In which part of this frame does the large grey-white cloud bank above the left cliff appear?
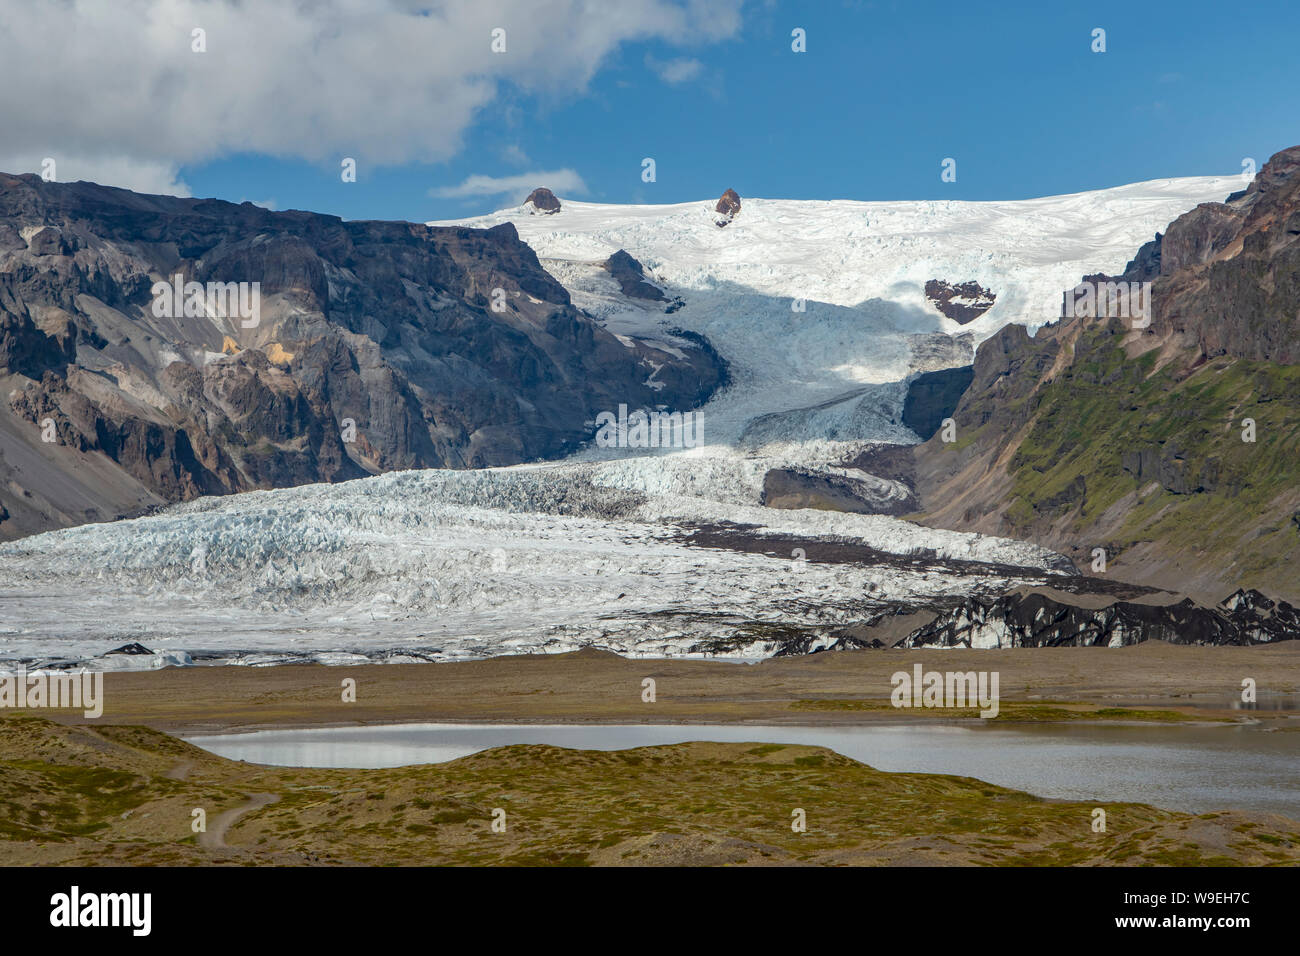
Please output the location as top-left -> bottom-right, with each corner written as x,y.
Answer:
0,0 -> 742,191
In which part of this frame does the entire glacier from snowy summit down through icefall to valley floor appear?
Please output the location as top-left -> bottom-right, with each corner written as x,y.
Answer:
0,177 -> 1239,667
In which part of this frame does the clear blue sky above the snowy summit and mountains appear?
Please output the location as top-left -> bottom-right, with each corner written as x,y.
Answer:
10,0 -> 1300,220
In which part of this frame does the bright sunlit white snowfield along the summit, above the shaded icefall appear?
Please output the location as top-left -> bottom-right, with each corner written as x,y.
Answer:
430,176 -> 1242,336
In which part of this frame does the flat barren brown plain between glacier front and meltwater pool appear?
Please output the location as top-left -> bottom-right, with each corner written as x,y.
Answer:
32,641 -> 1300,734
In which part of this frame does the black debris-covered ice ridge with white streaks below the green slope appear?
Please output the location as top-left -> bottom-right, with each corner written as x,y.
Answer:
898,591 -> 1300,648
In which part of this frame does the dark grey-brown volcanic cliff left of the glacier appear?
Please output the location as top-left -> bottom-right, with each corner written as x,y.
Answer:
0,174 -> 723,538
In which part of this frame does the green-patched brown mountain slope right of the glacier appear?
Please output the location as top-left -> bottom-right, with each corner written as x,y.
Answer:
904,147 -> 1300,602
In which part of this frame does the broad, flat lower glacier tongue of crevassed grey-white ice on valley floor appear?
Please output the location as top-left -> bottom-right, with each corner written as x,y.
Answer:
0,458 -> 1054,661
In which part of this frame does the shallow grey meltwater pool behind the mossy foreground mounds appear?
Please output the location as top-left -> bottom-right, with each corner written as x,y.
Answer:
186,722 -> 1300,819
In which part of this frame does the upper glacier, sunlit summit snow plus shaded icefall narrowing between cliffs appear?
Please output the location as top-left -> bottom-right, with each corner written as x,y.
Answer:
430,177 -> 1240,450
